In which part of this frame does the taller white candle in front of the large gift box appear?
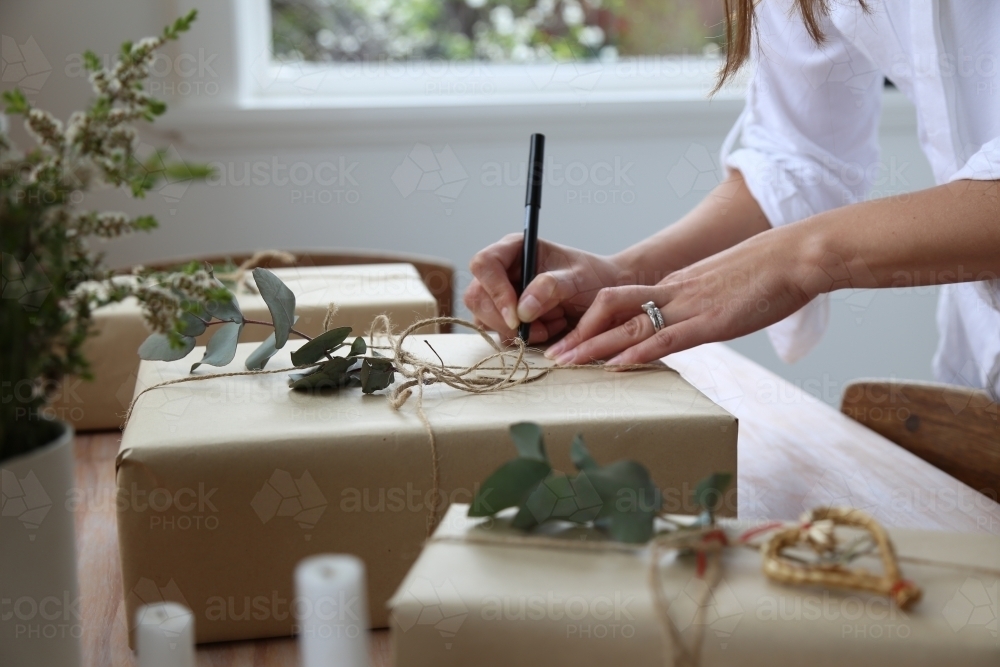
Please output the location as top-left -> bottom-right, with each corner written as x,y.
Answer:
295,555 -> 369,667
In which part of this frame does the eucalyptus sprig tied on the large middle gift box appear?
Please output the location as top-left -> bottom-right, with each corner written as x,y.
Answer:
139,267 -> 395,394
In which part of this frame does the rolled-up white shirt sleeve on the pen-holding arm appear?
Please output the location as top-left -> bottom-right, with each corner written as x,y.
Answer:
722,0 -> 883,362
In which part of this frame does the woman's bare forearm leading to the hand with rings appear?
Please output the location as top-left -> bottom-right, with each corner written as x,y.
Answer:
788,181 -> 1000,296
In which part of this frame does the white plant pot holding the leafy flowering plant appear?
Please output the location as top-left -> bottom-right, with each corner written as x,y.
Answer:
0,424 -> 82,667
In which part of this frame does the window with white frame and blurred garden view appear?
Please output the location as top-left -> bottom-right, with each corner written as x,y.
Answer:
242,0 -> 722,109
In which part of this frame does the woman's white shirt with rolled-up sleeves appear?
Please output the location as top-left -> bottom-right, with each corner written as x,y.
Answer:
722,0 -> 1000,399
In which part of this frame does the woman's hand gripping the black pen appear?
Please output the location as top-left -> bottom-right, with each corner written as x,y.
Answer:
464,234 -> 630,343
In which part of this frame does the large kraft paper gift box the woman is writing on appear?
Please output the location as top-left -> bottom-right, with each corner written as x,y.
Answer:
117,334 -> 737,642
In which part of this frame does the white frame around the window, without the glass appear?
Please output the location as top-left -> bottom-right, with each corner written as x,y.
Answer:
235,0 -> 732,108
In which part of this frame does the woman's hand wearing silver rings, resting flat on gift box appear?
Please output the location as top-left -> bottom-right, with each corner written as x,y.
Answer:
546,228 -> 820,364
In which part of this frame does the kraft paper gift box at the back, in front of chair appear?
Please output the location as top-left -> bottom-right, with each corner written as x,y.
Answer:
50,264 -> 437,431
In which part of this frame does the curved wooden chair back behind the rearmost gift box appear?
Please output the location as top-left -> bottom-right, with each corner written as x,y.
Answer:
135,249 -> 455,333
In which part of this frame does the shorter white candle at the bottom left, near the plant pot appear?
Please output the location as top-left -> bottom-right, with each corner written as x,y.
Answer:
135,602 -> 194,667
